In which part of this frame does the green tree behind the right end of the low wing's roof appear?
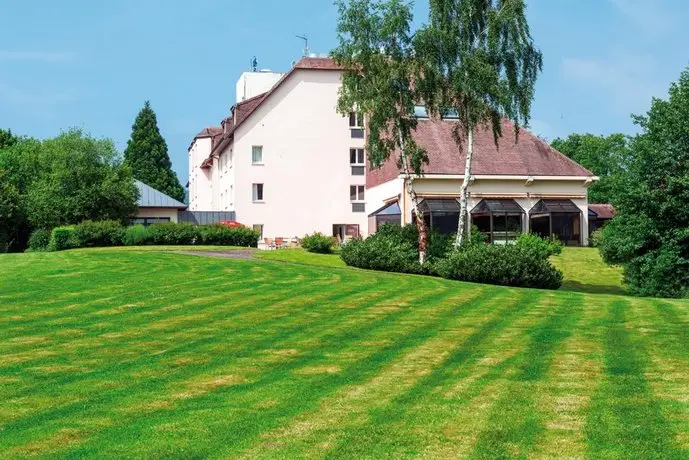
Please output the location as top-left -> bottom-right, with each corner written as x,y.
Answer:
552,134 -> 631,203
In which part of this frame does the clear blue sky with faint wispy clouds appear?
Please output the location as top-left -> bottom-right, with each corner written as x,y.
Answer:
0,0 -> 689,183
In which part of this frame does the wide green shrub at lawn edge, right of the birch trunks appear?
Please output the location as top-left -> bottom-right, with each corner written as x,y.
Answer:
435,244 -> 562,289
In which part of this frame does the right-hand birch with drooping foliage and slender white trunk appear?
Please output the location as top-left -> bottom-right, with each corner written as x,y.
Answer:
415,0 -> 542,246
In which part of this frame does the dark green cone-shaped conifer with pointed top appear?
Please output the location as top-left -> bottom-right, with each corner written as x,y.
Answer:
124,101 -> 184,201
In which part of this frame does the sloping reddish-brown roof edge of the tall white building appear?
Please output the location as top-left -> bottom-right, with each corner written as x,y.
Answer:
211,57 -> 342,156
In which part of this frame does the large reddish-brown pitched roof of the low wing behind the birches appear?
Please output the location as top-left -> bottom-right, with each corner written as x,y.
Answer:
366,120 -> 594,187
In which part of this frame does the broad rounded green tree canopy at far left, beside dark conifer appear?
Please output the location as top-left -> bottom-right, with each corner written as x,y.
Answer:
0,130 -> 138,250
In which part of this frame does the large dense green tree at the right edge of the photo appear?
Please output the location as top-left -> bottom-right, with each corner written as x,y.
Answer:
600,69 -> 689,297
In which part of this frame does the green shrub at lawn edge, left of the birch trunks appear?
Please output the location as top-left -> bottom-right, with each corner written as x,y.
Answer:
340,237 -> 423,273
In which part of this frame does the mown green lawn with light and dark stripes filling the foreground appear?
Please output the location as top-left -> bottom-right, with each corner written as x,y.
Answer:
0,250 -> 689,458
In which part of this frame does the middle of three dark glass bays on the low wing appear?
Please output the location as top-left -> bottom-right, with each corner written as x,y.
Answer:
471,199 -> 525,244
